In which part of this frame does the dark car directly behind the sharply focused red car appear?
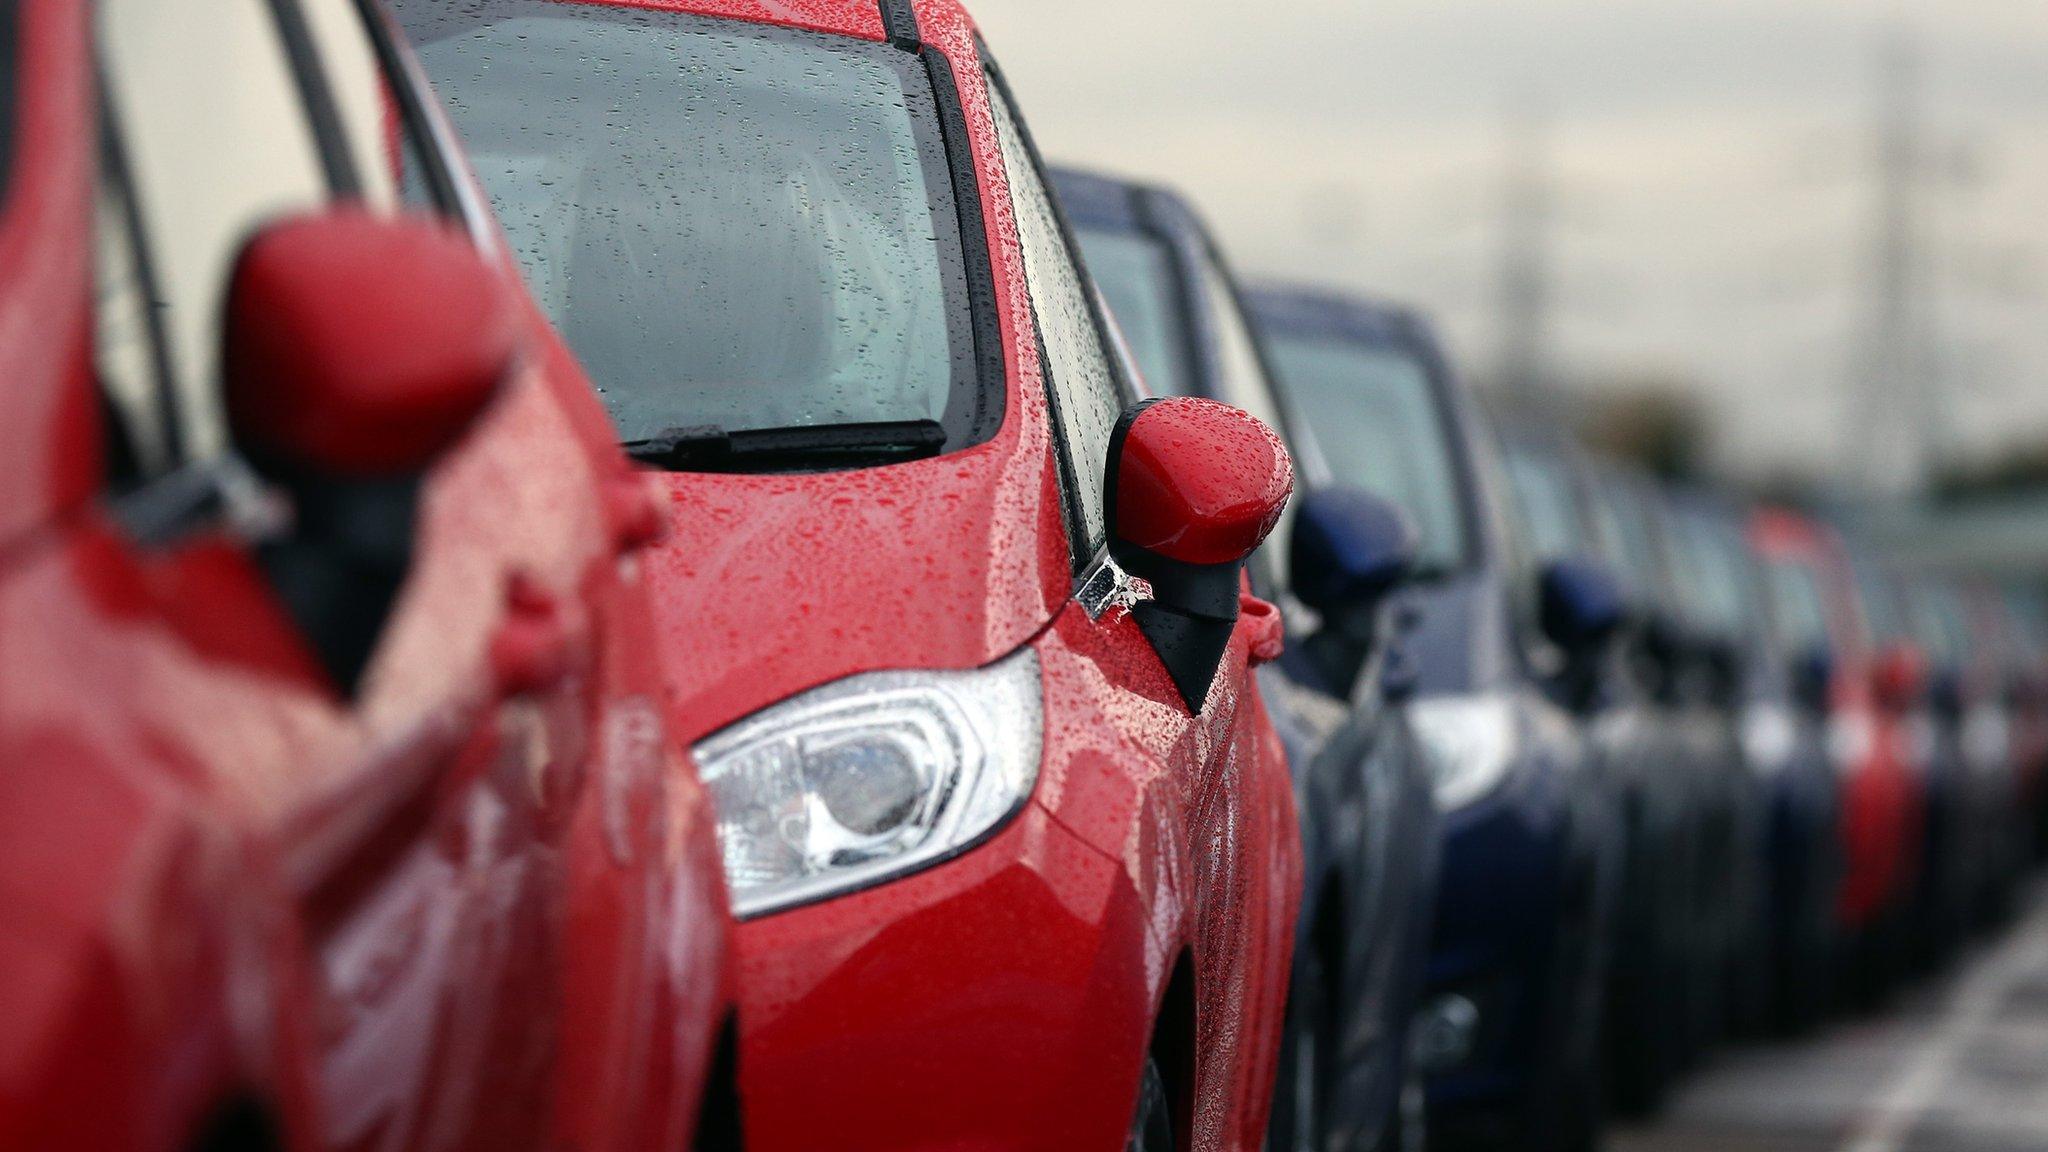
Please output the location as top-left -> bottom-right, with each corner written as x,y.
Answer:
1053,172 -> 1438,1152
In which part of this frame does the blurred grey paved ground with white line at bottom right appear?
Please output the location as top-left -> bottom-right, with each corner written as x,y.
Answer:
1612,888 -> 2048,1152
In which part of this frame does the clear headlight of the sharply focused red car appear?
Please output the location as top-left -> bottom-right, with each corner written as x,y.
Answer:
696,648 -> 1044,918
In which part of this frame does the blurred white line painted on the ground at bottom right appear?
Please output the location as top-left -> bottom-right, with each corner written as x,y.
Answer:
1841,914 -> 2048,1152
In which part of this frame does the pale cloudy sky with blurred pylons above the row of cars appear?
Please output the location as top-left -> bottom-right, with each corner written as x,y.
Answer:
975,0 -> 2048,572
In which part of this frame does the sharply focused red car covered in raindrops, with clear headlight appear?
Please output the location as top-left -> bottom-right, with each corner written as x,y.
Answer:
397,0 -> 1300,1152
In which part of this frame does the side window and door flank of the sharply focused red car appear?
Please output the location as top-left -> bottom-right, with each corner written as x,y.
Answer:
989,62 -> 1300,1146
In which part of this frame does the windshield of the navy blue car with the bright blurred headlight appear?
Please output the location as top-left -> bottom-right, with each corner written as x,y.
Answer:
1268,330 -> 1466,574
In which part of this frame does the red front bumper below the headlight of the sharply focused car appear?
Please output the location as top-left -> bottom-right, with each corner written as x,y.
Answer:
737,804 -> 1167,1152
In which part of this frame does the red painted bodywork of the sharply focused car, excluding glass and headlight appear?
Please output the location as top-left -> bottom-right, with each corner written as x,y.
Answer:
485,0 -> 1300,1152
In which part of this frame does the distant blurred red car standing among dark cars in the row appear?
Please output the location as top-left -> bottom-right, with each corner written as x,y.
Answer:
1751,510 -> 1921,931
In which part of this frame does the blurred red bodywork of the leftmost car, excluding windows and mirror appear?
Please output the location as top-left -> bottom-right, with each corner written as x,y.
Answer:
0,0 -> 729,1152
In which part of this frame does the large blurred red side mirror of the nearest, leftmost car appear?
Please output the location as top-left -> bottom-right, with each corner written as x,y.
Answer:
221,207 -> 520,480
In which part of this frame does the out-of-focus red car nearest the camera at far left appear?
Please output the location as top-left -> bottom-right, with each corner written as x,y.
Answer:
0,0 -> 733,1152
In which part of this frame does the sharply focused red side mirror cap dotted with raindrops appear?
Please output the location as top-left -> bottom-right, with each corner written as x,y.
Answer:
1108,396 -> 1294,566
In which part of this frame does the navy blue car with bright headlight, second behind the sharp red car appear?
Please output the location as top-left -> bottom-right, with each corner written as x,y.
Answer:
1247,289 -> 1622,1150
